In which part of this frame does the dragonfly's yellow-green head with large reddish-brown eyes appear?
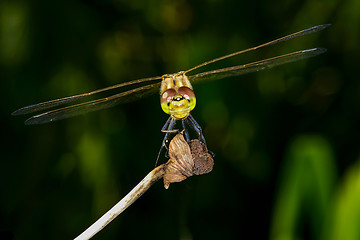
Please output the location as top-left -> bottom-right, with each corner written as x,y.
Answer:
160,87 -> 196,119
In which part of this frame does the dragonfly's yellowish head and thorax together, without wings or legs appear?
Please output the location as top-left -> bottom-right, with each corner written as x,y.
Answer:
160,72 -> 196,119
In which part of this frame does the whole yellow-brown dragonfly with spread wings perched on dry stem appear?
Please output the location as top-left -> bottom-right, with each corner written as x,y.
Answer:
12,24 -> 330,156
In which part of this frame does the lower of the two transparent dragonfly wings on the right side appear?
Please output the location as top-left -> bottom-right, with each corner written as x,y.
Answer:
188,48 -> 326,83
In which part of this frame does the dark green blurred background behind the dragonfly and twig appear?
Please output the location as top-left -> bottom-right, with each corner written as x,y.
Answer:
0,0 -> 360,240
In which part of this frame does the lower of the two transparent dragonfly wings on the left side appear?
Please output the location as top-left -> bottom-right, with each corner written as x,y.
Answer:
25,83 -> 160,125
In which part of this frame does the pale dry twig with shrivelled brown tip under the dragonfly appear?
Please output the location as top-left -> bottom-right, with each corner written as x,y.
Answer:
75,133 -> 214,240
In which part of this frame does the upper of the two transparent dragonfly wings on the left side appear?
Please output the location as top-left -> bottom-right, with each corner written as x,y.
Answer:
12,77 -> 161,115
